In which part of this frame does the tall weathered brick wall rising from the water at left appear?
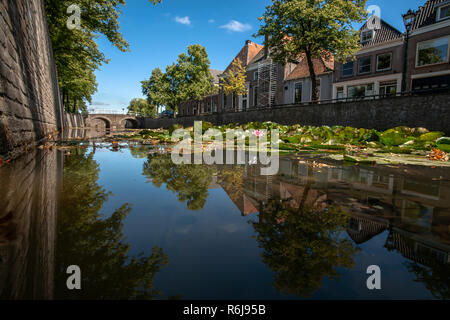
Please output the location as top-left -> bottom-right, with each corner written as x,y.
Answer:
0,0 -> 63,157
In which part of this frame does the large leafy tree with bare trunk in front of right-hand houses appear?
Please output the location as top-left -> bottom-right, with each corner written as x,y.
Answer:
256,0 -> 367,101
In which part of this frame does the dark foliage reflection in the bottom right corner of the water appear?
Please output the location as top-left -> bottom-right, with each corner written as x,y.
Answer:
405,262 -> 450,300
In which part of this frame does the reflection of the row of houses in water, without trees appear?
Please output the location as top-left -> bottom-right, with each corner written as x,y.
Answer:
222,158 -> 450,248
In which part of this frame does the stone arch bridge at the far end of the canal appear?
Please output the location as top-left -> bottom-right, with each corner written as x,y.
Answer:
85,113 -> 141,130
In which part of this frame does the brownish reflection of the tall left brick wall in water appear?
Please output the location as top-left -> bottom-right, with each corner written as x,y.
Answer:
0,150 -> 63,299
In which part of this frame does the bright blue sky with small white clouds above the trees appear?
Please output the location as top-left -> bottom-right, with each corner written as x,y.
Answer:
91,0 -> 425,110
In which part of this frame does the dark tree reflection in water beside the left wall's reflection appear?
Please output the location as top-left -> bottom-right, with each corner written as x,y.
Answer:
55,150 -> 168,299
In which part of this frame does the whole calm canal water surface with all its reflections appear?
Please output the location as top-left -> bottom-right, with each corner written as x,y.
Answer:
0,133 -> 450,299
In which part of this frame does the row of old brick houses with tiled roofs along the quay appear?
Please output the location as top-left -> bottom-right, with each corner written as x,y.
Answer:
180,0 -> 450,116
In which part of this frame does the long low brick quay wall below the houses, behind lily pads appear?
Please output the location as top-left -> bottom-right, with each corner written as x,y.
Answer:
142,93 -> 450,134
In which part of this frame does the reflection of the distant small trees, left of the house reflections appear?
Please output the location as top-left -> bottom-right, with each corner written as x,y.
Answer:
144,154 -> 213,210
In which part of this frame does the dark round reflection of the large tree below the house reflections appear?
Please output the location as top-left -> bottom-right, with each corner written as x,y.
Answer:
252,199 -> 358,297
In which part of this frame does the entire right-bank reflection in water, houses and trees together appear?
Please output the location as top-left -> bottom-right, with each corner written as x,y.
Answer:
144,155 -> 450,299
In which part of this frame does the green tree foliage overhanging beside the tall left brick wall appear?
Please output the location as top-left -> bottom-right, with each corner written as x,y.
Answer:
44,0 -> 161,112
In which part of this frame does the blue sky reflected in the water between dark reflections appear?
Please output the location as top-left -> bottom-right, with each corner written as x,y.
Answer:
90,149 -> 446,299
